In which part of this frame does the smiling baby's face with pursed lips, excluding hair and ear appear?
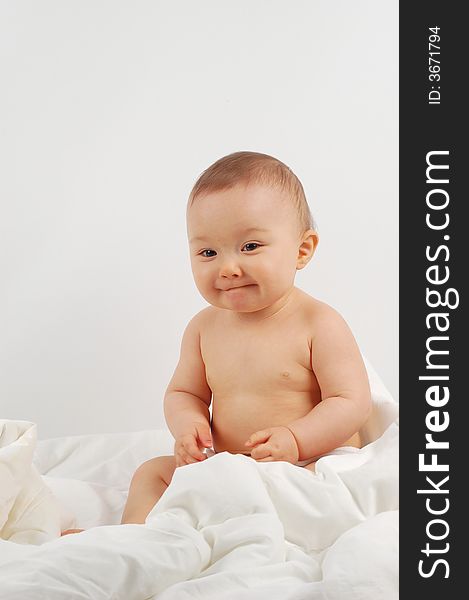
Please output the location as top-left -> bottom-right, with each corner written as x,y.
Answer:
187,185 -> 308,312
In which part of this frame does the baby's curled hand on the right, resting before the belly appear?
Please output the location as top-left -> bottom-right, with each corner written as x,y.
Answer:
245,427 -> 299,464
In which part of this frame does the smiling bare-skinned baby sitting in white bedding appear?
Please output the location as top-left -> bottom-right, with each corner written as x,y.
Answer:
122,152 -> 371,523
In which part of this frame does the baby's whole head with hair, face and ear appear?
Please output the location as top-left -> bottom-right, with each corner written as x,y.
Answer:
187,152 -> 318,313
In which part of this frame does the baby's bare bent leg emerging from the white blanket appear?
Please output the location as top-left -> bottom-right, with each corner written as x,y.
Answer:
121,456 -> 176,523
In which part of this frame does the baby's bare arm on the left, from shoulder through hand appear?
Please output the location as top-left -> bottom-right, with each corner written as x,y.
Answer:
164,311 -> 212,466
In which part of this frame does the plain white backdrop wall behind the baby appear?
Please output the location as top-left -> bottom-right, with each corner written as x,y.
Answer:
0,0 -> 398,438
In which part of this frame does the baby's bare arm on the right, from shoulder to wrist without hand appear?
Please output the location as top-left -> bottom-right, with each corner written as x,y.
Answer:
288,305 -> 371,460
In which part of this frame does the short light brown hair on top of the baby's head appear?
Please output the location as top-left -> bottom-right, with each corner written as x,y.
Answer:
188,151 -> 316,233
